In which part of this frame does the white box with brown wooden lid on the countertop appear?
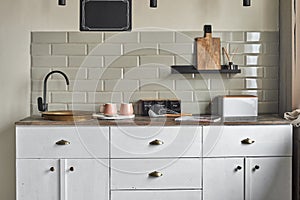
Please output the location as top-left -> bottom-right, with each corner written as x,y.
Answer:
213,95 -> 258,117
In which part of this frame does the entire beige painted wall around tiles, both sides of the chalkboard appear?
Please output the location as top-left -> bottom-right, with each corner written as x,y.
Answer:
0,0 -> 278,200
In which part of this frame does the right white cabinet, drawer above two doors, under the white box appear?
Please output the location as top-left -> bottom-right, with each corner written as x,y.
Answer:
203,126 -> 292,200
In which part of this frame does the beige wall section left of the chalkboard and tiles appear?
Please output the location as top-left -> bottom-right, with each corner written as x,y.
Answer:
0,0 -> 78,200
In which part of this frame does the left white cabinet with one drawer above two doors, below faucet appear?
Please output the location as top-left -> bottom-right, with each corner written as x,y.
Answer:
16,126 -> 109,200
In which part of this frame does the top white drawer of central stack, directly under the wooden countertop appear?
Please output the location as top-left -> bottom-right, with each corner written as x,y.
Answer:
111,126 -> 202,158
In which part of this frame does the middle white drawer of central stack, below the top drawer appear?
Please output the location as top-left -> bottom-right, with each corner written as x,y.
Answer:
111,158 -> 202,189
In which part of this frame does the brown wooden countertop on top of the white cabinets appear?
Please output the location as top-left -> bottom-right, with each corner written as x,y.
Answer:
15,115 -> 289,126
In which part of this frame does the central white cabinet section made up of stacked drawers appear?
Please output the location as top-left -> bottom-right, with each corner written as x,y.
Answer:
111,126 -> 202,200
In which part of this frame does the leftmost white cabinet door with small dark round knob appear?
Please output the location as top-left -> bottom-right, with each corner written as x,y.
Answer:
16,159 -> 60,200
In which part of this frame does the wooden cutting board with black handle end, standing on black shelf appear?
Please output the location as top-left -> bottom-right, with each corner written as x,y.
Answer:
195,25 -> 221,70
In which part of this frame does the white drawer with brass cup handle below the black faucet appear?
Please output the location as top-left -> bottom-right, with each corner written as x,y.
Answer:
16,126 -> 109,158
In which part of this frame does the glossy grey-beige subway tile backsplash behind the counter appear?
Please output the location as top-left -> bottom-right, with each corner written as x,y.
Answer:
31,31 -> 279,114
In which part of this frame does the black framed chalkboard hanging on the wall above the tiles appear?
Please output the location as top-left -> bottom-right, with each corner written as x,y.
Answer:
80,0 -> 132,31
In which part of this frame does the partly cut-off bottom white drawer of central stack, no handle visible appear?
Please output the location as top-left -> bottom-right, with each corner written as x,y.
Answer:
111,190 -> 202,200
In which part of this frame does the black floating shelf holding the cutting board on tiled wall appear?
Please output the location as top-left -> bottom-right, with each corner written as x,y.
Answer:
171,65 -> 241,74
